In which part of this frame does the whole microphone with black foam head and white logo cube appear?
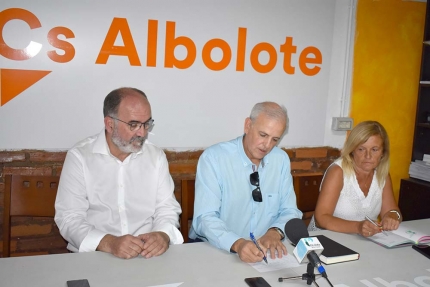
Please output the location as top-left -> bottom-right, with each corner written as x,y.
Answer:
285,218 -> 327,277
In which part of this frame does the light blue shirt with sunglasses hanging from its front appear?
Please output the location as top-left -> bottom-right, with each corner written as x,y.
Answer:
189,136 -> 302,251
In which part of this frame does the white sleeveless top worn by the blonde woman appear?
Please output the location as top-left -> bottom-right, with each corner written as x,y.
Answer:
308,159 -> 385,230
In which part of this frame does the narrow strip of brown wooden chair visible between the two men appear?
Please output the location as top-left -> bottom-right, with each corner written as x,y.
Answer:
181,179 -> 195,243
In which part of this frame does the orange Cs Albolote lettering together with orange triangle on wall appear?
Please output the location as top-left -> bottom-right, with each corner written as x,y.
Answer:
0,8 -> 322,106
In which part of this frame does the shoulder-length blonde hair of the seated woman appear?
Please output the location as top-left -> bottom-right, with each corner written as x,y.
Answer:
341,121 -> 390,187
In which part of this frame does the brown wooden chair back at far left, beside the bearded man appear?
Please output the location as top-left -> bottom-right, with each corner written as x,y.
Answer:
3,175 -> 60,257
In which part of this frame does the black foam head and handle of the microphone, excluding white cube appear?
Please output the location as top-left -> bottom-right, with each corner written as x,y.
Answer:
285,218 -> 327,277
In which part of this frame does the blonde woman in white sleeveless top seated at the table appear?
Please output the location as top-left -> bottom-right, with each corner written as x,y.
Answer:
308,121 -> 402,237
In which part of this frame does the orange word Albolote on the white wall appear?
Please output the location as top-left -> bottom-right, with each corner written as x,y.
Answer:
96,18 -> 322,76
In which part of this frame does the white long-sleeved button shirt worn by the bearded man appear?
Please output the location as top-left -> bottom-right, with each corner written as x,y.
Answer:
55,130 -> 184,252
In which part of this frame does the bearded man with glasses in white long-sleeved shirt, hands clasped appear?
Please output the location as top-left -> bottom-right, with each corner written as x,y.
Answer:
55,88 -> 183,259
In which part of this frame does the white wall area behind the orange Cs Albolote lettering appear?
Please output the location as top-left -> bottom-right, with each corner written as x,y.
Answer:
0,0 -> 355,150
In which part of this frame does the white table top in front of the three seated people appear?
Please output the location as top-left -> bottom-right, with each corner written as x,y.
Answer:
0,219 -> 430,287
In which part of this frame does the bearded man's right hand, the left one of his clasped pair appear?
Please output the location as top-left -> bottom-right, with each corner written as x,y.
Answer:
97,234 -> 143,259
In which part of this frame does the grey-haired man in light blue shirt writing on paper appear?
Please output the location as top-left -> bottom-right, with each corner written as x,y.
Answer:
189,102 -> 302,263
